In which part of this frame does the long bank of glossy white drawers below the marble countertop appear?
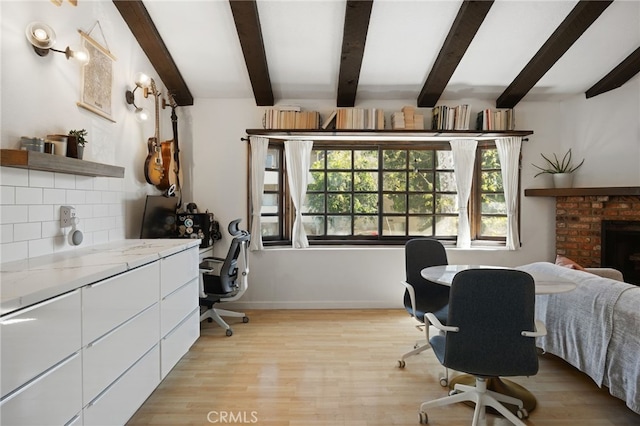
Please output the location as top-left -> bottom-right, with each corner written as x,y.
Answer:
0,246 -> 200,426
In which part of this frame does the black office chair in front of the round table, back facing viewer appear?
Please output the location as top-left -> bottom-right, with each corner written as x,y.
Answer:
420,269 -> 547,426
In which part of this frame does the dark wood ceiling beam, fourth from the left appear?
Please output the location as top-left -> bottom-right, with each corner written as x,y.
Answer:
417,0 -> 493,108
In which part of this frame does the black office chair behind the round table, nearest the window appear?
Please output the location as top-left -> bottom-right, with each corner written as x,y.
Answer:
398,238 -> 449,386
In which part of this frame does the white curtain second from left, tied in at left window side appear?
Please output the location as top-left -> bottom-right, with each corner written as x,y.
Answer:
284,141 -> 313,248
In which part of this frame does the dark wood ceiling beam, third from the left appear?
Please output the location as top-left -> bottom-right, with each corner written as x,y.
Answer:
336,0 -> 373,107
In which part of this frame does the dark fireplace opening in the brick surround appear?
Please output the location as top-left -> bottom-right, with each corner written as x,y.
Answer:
601,220 -> 640,285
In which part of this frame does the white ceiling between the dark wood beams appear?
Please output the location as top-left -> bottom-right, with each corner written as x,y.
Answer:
144,0 -> 640,104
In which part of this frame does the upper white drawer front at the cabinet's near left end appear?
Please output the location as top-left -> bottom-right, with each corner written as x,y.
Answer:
0,290 -> 82,398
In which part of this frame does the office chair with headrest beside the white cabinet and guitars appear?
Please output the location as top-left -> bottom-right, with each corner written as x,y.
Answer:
200,219 -> 251,336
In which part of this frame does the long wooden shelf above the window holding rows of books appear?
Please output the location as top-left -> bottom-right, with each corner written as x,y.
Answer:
246,129 -> 533,141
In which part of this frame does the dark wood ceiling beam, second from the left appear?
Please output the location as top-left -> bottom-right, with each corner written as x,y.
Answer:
229,0 -> 274,106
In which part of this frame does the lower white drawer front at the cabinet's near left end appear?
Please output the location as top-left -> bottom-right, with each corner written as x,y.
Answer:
0,351 -> 82,425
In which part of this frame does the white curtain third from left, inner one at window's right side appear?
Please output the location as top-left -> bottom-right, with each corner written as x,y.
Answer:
449,139 -> 478,248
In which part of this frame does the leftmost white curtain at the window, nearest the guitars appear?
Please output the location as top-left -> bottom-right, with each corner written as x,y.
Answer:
249,136 -> 269,250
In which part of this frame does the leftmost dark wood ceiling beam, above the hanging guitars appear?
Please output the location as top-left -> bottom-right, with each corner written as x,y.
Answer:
113,0 -> 193,106
